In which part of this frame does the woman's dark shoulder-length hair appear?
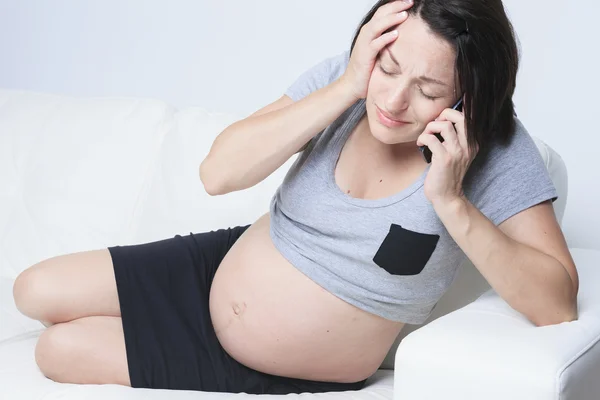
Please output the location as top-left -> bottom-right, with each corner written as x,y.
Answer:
350,0 -> 519,158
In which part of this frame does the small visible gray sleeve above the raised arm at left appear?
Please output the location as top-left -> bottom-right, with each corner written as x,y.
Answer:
285,51 -> 350,101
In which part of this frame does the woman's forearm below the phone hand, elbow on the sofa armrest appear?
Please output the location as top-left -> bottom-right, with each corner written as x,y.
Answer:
434,197 -> 577,326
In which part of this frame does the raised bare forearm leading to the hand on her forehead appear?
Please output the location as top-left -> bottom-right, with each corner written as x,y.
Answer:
201,80 -> 356,193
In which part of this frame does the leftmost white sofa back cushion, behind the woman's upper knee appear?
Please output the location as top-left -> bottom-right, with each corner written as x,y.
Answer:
0,90 -> 175,277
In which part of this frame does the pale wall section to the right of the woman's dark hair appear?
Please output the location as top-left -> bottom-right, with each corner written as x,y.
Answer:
504,0 -> 600,249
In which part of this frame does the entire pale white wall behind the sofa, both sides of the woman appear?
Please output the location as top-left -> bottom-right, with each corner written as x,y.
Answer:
0,0 -> 600,249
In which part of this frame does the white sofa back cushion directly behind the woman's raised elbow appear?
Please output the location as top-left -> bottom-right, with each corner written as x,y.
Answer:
125,107 -> 297,243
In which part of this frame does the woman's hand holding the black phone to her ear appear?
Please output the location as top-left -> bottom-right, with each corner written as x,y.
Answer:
417,108 -> 479,205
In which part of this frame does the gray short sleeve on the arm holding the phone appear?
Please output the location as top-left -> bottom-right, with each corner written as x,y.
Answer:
464,120 -> 558,226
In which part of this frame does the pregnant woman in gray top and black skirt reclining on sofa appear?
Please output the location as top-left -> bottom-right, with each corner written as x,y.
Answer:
14,0 -> 578,394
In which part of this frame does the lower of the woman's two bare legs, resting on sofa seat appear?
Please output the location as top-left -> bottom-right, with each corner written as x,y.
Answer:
35,316 -> 131,386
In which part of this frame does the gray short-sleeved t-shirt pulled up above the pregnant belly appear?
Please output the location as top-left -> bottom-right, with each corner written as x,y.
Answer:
270,52 -> 557,324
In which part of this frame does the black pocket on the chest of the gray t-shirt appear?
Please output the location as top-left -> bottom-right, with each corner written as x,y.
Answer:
373,224 -> 440,275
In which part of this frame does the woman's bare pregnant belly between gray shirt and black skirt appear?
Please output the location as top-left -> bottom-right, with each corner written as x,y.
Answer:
210,214 -> 403,382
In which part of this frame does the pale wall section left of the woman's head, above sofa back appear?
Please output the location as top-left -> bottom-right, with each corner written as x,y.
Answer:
0,0 -> 372,114
